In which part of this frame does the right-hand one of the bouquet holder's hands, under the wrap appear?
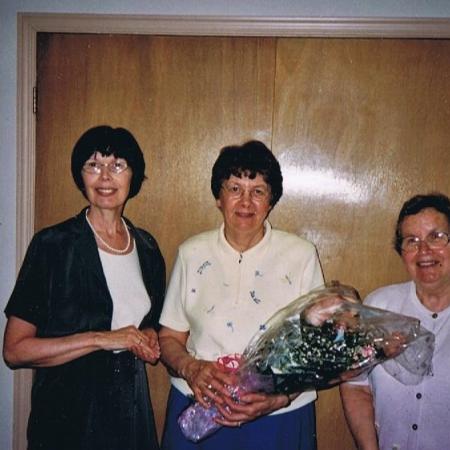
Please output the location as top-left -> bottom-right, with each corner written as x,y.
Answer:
216,393 -> 290,427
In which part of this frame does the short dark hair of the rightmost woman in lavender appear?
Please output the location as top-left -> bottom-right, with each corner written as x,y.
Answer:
394,192 -> 450,255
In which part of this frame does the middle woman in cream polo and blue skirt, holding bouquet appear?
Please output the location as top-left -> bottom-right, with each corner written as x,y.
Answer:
160,141 -> 323,450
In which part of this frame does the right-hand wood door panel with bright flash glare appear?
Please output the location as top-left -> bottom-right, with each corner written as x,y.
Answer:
272,39 -> 450,450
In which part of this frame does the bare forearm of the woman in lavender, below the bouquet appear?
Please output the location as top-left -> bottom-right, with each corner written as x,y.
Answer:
339,383 -> 378,450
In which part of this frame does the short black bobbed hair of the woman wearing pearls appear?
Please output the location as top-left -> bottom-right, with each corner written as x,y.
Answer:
72,125 -> 146,198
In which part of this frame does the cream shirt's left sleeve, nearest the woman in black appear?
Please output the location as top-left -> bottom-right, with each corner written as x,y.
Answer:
159,249 -> 189,331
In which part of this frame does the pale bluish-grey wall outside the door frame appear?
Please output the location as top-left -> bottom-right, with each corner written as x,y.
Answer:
0,0 -> 450,450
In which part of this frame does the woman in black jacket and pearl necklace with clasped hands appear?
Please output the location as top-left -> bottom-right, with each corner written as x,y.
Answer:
3,126 -> 165,450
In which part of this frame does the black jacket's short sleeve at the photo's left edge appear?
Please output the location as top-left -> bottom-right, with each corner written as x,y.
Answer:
5,234 -> 48,328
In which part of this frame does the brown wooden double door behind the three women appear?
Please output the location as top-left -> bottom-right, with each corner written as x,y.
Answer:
36,34 -> 450,450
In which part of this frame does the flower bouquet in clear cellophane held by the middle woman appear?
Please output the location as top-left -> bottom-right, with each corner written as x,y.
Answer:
178,282 -> 434,442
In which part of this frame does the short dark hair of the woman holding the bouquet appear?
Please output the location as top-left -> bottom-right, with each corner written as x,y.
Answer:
211,140 -> 283,208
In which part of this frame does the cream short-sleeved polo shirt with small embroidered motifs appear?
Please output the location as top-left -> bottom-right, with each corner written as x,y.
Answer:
160,221 -> 323,412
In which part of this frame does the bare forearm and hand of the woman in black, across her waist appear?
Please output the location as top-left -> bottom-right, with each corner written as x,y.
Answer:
3,316 -> 155,368
